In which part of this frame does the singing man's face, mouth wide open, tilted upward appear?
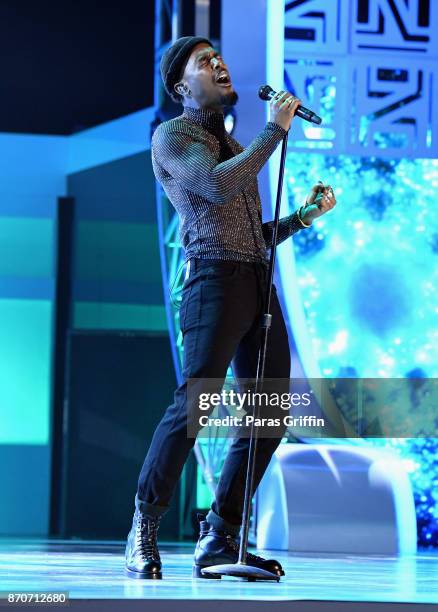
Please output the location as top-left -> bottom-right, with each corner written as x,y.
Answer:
180,43 -> 237,109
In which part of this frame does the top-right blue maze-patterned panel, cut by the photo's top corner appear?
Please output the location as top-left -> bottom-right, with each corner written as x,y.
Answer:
351,0 -> 438,57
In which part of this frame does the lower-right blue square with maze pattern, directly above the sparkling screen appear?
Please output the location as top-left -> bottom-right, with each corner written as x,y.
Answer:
346,56 -> 438,158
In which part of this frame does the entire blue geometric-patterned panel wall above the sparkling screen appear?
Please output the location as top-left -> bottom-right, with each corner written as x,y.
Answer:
284,0 -> 438,158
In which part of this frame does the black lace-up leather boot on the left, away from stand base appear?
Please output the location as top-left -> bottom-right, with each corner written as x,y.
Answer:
125,508 -> 162,579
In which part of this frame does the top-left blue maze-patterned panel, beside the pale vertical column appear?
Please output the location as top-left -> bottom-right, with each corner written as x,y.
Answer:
284,0 -> 350,57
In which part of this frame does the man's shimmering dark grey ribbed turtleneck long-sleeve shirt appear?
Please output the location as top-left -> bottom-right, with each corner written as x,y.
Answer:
151,107 -> 303,263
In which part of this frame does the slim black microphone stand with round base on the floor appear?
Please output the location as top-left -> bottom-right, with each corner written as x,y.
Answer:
201,132 -> 289,582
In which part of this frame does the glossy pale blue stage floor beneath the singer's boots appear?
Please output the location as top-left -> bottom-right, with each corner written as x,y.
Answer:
0,538 -> 438,612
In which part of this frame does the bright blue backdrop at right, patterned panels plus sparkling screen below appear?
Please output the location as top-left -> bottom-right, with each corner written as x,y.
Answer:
280,0 -> 438,546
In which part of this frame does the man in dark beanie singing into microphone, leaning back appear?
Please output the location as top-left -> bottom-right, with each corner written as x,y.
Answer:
126,36 -> 336,578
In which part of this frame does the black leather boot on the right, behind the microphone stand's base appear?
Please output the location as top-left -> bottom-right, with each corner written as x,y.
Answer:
192,514 -> 284,579
